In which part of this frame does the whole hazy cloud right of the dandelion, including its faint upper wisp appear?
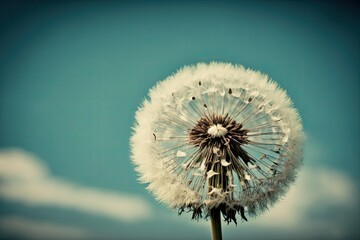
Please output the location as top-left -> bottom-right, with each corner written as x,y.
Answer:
242,134 -> 360,239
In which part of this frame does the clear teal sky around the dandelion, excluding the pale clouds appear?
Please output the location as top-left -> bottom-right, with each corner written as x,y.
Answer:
0,1 -> 360,239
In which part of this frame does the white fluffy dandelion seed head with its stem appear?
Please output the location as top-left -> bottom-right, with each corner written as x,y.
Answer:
131,62 -> 303,239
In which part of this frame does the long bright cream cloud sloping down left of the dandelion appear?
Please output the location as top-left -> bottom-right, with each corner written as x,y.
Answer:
0,150 -> 151,222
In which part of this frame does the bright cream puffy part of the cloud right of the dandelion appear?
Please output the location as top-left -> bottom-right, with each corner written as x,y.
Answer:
254,168 -> 357,228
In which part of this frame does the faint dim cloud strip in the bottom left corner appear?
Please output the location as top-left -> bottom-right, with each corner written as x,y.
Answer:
0,216 -> 91,240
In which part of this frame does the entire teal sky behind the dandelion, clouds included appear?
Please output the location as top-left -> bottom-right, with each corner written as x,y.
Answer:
0,1 -> 360,240
